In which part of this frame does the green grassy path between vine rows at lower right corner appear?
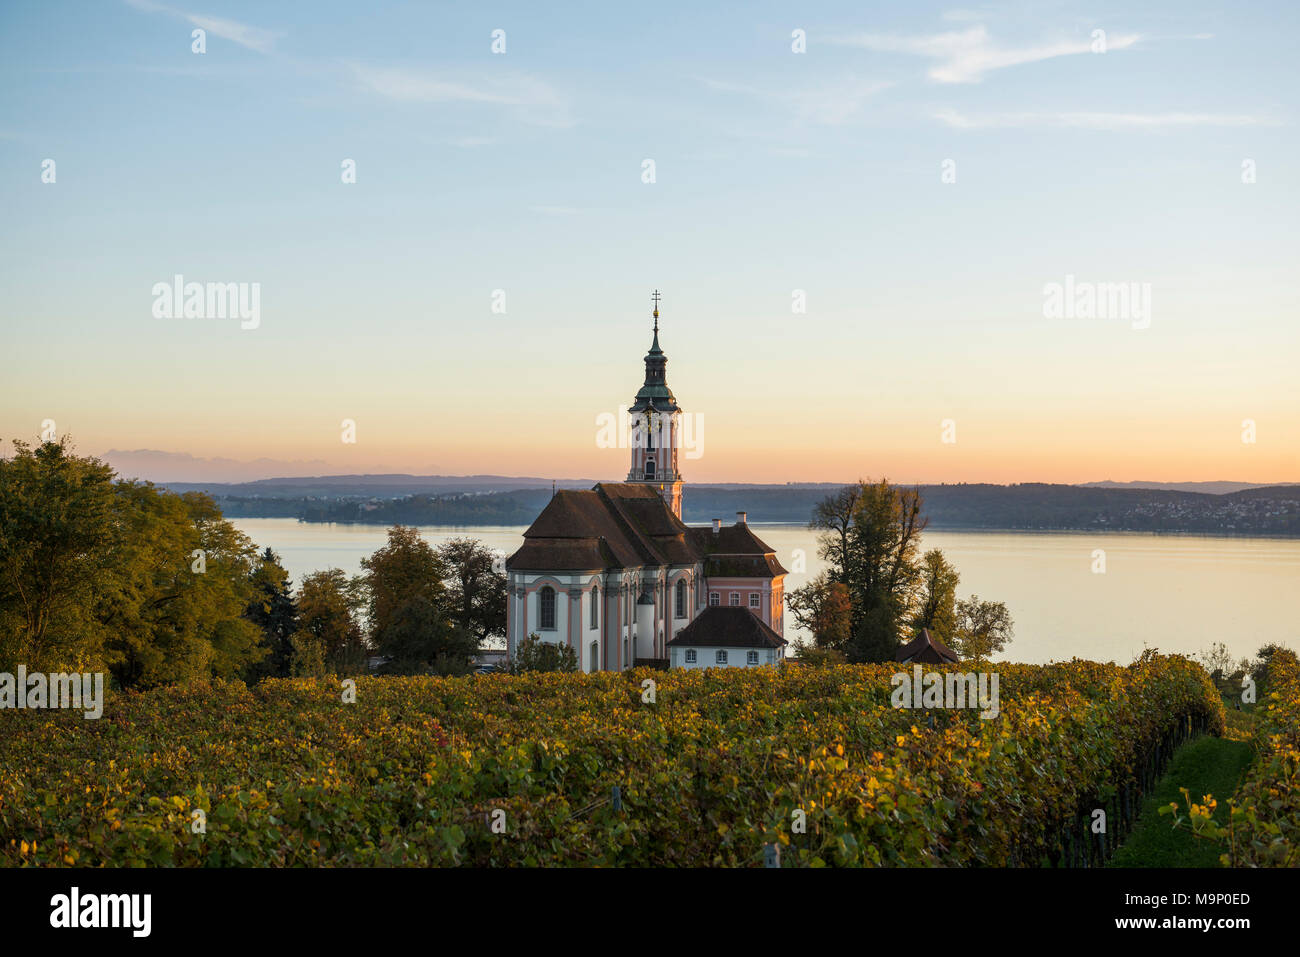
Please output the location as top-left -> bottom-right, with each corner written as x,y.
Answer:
1110,719 -> 1255,867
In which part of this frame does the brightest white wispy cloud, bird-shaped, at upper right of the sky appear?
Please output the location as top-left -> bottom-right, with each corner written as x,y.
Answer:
828,26 -> 1140,83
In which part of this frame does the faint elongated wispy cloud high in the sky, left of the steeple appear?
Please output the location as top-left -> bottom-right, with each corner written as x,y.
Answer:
352,65 -> 573,126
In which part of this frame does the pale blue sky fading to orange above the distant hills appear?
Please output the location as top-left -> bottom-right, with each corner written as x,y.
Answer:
0,0 -> 1300,484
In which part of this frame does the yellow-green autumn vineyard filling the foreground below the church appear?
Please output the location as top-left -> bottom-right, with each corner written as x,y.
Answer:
0,654 -> 1300,866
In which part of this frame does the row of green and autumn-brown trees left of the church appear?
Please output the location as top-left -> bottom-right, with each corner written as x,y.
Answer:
0,438 -> 506,688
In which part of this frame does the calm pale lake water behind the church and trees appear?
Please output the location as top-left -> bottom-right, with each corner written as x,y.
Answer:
231,519 -> 1300,664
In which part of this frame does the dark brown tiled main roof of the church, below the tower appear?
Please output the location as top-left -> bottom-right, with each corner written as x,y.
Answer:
506,482 -> 787,577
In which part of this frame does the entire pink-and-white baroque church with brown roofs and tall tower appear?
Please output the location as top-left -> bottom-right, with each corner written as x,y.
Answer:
506,291 -> 787,672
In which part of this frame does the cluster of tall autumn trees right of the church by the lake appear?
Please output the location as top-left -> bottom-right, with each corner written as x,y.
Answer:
787,480 -> 1014,662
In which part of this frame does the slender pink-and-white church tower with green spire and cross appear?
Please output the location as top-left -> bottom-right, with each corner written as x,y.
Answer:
628,289 -> 681,519
